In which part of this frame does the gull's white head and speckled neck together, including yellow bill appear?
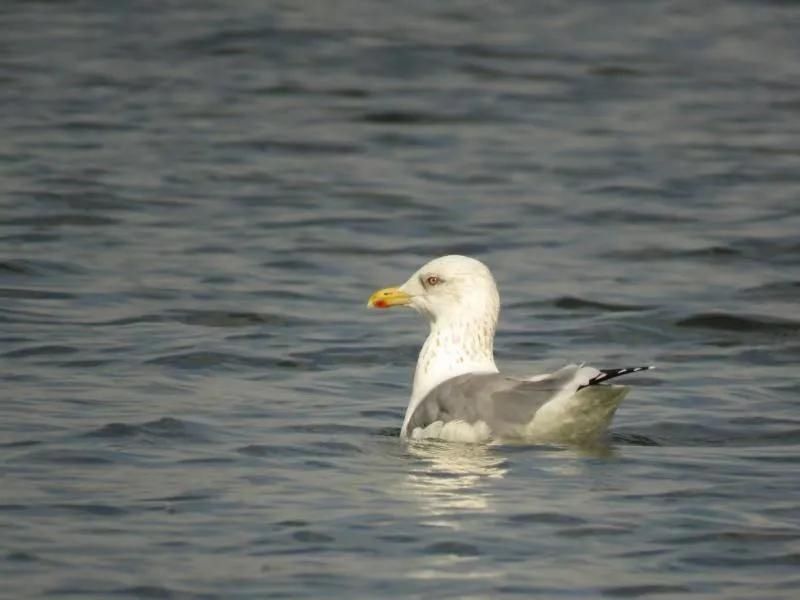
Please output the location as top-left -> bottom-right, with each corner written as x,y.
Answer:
367,255 -> 500,435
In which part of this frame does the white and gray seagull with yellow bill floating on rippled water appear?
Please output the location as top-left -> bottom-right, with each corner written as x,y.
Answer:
367,255 -> 653,444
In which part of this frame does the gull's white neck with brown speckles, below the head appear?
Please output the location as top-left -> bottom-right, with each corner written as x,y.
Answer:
401,311 -> 497,435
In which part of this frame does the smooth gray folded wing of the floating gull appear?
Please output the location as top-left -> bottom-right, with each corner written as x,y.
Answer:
406,365 -> 580,437
